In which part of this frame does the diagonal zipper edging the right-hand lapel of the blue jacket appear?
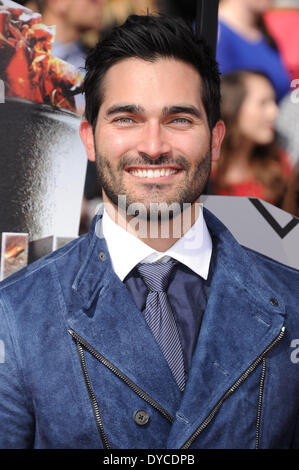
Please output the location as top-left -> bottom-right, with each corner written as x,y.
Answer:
181,326 -> 285,449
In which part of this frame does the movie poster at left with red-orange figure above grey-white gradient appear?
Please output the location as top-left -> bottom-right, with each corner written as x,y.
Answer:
0,0 -> 87,278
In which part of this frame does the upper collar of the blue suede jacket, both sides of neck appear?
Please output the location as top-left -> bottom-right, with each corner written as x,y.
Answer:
72,207 -> 285,313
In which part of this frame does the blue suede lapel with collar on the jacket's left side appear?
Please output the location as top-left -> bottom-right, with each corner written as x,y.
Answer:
68,213 -> 181,416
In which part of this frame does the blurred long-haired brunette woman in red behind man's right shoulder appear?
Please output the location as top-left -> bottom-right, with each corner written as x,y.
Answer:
211,71 -> 291,205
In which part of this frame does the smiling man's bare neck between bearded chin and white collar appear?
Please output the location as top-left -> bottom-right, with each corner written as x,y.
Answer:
103,194 -> 200,252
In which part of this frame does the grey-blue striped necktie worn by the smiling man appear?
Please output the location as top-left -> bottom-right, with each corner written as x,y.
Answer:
137,260 -> 185,391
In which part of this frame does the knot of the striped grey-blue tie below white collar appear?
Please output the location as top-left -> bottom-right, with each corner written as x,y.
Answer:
137,260 -> 176,292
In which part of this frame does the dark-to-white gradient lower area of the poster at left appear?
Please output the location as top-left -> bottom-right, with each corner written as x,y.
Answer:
0,98 -> 87,240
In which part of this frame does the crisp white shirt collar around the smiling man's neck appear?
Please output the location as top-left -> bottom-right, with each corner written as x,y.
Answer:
102,204 -> 212,281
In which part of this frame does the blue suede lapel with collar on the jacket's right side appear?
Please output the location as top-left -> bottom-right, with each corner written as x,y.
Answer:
168,211 -> 285,448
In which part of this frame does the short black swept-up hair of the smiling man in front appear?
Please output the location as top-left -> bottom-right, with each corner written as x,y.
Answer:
83,15 -> 220,129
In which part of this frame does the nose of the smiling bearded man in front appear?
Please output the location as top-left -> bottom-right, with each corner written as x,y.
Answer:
137,122 -> 171,160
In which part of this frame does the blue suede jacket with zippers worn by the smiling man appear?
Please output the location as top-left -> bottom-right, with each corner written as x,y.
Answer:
0,210 -> 299,449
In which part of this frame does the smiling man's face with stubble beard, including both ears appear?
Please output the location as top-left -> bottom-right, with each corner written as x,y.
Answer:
81,58 -> 224,217
